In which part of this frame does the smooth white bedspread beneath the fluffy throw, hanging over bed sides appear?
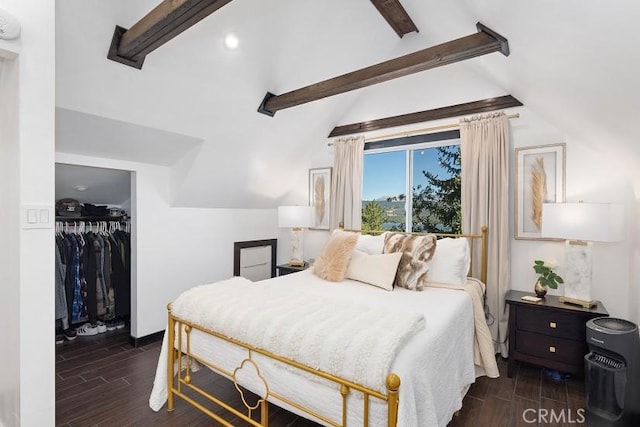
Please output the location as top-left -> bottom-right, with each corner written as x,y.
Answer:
149,270 -> 486,427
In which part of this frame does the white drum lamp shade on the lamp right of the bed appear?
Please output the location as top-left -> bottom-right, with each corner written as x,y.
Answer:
540,203 -> 623,242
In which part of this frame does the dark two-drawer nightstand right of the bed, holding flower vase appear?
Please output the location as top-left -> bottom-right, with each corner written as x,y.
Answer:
506,290 -> 609,377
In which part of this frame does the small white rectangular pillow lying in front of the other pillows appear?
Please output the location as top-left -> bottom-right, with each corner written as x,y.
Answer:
346,250 -> 402,291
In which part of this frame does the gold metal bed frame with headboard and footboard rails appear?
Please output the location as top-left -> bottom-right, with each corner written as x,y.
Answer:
167,227 -> 487,427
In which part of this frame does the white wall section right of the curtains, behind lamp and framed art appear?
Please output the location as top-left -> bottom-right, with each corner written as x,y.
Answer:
509,108 -> 633,318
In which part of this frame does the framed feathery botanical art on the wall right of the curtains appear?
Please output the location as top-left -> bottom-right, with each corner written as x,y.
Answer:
514,144 -> 565,240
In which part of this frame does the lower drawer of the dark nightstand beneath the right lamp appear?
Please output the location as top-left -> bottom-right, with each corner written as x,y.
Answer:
515,331 -> 587,366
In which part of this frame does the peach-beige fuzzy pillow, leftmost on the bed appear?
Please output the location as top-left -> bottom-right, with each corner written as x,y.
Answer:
313,230 -> 358,282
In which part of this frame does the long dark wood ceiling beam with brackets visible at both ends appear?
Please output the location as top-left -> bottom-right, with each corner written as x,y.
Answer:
258,23 -> 509,116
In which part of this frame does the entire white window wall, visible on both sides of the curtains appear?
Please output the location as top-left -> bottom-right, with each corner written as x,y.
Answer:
298,107 -> 640,321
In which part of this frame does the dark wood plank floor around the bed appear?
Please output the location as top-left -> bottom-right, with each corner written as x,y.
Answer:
56,329 -> 584,427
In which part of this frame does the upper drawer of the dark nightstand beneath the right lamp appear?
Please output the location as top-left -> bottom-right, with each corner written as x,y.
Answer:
516,307 -> 586,342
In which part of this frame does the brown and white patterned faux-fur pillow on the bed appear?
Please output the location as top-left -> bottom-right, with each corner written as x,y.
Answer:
383,233 -> 436,291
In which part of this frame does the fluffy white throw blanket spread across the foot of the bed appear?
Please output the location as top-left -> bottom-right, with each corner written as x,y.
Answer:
172,277 -> 424,393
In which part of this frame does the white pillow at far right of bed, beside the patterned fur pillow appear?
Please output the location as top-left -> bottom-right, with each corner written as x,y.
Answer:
426,237 -> 471,289
